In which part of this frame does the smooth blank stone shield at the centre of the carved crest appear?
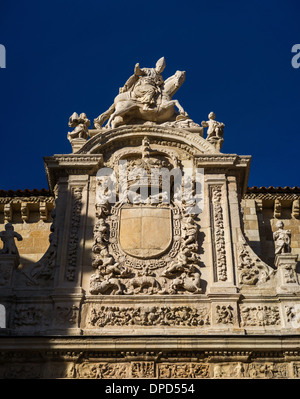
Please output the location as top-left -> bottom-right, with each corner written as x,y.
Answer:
119,206 -> 173,259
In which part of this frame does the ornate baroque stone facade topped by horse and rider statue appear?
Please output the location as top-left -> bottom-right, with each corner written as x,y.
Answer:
0,58 -> 300,379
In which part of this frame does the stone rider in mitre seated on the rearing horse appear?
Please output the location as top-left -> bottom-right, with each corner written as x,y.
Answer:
120,57 -> 166,111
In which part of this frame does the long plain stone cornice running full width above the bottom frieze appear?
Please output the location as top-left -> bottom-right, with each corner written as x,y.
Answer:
0,334 -> 300,356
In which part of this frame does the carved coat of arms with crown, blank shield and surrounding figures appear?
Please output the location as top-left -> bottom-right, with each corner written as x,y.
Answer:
90,142 -> 202,295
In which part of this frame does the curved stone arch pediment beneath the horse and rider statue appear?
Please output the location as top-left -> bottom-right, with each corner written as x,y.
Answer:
77,125 -> 221,155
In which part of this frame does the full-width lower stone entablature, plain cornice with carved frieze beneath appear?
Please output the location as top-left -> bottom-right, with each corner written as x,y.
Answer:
0,336 -> 300,379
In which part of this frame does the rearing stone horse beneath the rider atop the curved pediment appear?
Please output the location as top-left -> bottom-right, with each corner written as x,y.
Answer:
94,71 -> 188,129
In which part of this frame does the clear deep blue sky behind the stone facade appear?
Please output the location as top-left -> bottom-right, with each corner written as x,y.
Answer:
0,0 -> 300,190
